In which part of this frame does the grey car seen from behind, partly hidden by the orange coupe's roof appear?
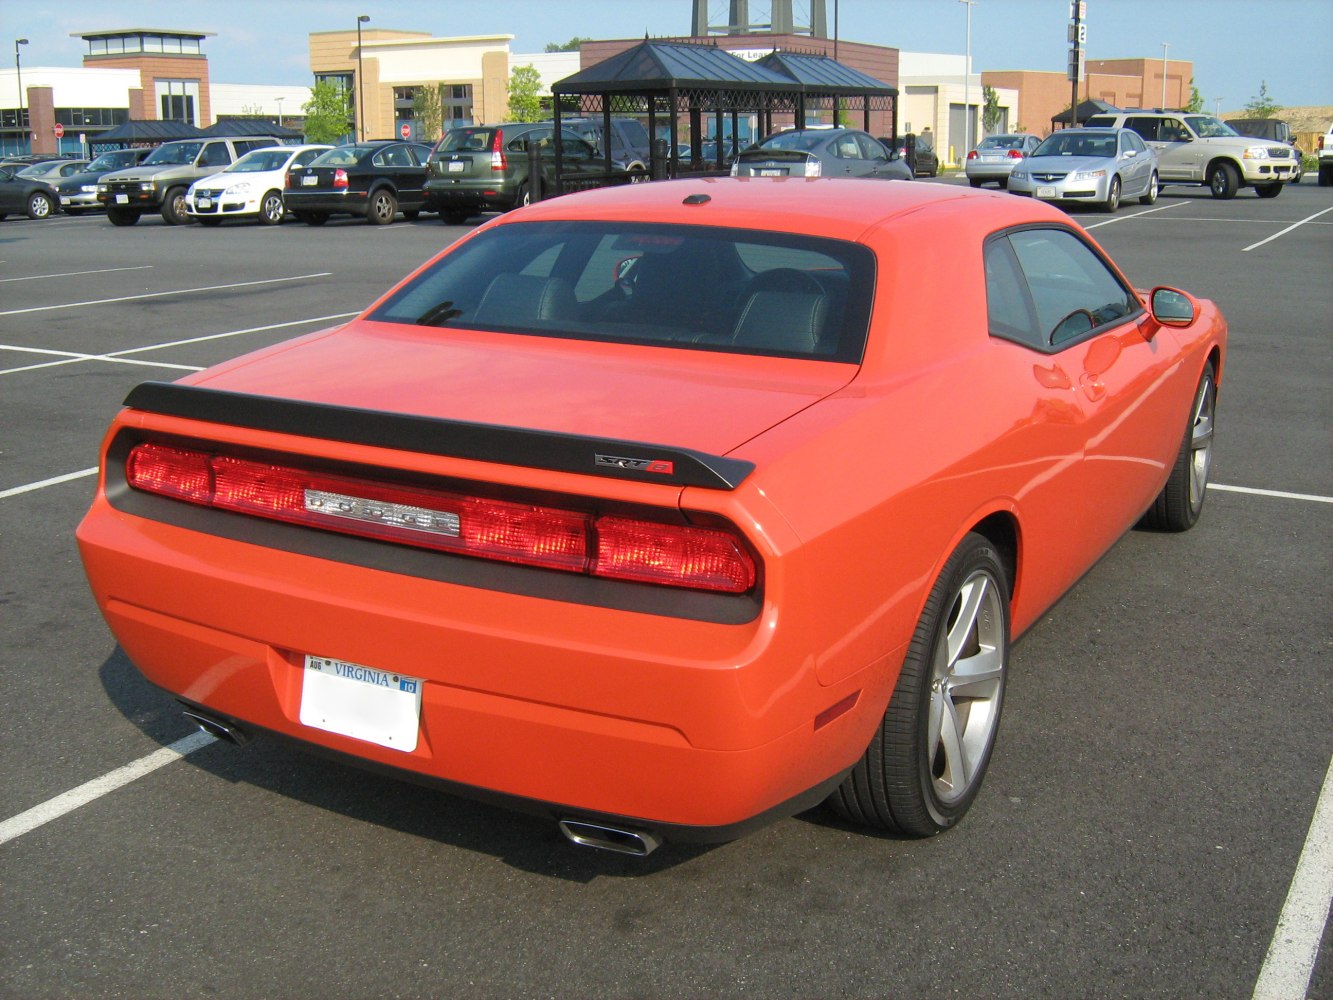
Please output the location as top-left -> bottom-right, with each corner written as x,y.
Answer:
732,128 -> 912,180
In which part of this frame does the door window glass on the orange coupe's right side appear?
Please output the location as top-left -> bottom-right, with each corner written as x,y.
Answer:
1009,229 -> 1141,348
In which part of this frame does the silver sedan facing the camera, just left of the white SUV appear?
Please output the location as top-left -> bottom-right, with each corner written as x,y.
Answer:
1009,128 -> 1158,212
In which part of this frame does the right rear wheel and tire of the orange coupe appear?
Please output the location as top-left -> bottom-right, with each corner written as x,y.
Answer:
828,533 -> 1009,836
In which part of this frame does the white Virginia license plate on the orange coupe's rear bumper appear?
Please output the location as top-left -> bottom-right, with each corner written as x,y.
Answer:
300,655 -> 425,753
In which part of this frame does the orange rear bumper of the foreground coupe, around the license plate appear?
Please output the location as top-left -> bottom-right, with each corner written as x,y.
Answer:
79,493 -> 885,840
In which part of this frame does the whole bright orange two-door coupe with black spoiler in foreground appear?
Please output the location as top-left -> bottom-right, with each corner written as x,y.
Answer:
79,179 -> 1226,853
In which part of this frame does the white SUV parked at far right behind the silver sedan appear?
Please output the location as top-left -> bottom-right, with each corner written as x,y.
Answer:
1085,108 -> 1297,199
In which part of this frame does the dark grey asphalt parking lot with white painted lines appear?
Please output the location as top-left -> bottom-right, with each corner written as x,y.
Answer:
0,179 -> 1333,1000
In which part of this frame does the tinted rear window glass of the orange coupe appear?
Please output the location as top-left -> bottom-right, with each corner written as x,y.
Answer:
371,221 -> 874,363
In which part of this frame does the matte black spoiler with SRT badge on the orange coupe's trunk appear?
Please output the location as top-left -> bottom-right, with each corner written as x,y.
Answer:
125,381 -> 754,489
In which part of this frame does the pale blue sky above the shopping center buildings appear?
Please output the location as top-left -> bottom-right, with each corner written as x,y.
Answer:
10,0 -> 1333,112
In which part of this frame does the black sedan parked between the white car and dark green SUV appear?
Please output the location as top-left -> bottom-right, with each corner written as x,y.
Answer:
284,140 -> 431,225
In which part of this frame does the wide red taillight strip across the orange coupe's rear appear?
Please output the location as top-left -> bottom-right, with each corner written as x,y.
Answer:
125,443 -> 756,593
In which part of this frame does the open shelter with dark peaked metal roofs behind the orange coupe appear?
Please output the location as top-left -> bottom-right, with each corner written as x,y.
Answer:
551,39 -> 898,177
